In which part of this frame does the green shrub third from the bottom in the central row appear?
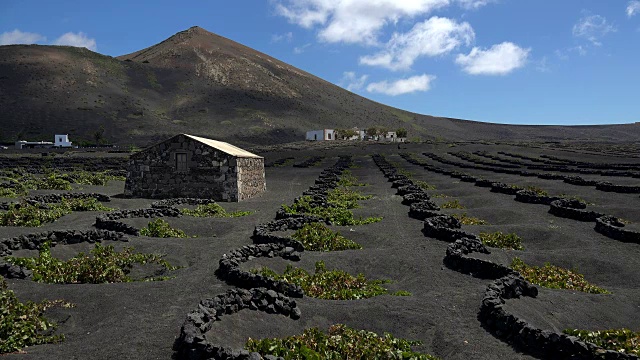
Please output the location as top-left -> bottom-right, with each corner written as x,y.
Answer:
291,223 -> 362,251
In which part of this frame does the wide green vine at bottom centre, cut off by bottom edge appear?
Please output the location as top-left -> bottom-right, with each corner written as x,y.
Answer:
245,324 -> 437,360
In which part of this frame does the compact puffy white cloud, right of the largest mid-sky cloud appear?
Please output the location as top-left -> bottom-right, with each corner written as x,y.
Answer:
456,42 -> 531,75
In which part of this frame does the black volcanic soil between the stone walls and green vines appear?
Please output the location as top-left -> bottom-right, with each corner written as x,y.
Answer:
0,144 -> 640,359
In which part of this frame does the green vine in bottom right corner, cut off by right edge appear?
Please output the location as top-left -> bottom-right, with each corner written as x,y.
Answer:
563,329 -> 640,356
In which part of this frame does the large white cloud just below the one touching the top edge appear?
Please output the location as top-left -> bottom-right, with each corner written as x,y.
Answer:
360,16 -> 475,70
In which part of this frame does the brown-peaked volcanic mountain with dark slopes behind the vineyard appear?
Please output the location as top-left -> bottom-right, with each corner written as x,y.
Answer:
0,27 -> 640,145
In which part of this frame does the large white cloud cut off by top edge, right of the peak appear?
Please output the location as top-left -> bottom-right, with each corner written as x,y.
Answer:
275,0 -> 450,44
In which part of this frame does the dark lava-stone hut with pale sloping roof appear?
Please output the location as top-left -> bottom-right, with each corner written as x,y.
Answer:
124,134 -> 266,201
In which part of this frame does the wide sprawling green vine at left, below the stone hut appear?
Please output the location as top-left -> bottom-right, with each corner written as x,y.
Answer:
6,243 -> 176,284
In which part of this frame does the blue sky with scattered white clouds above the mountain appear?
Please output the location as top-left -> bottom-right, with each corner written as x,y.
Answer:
0,0 -> 640,125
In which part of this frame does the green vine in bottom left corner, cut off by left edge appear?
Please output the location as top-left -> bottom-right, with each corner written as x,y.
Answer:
0,277 -> 74,354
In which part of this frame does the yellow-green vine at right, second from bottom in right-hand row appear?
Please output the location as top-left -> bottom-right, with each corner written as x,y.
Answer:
511,257 -> 611,294
